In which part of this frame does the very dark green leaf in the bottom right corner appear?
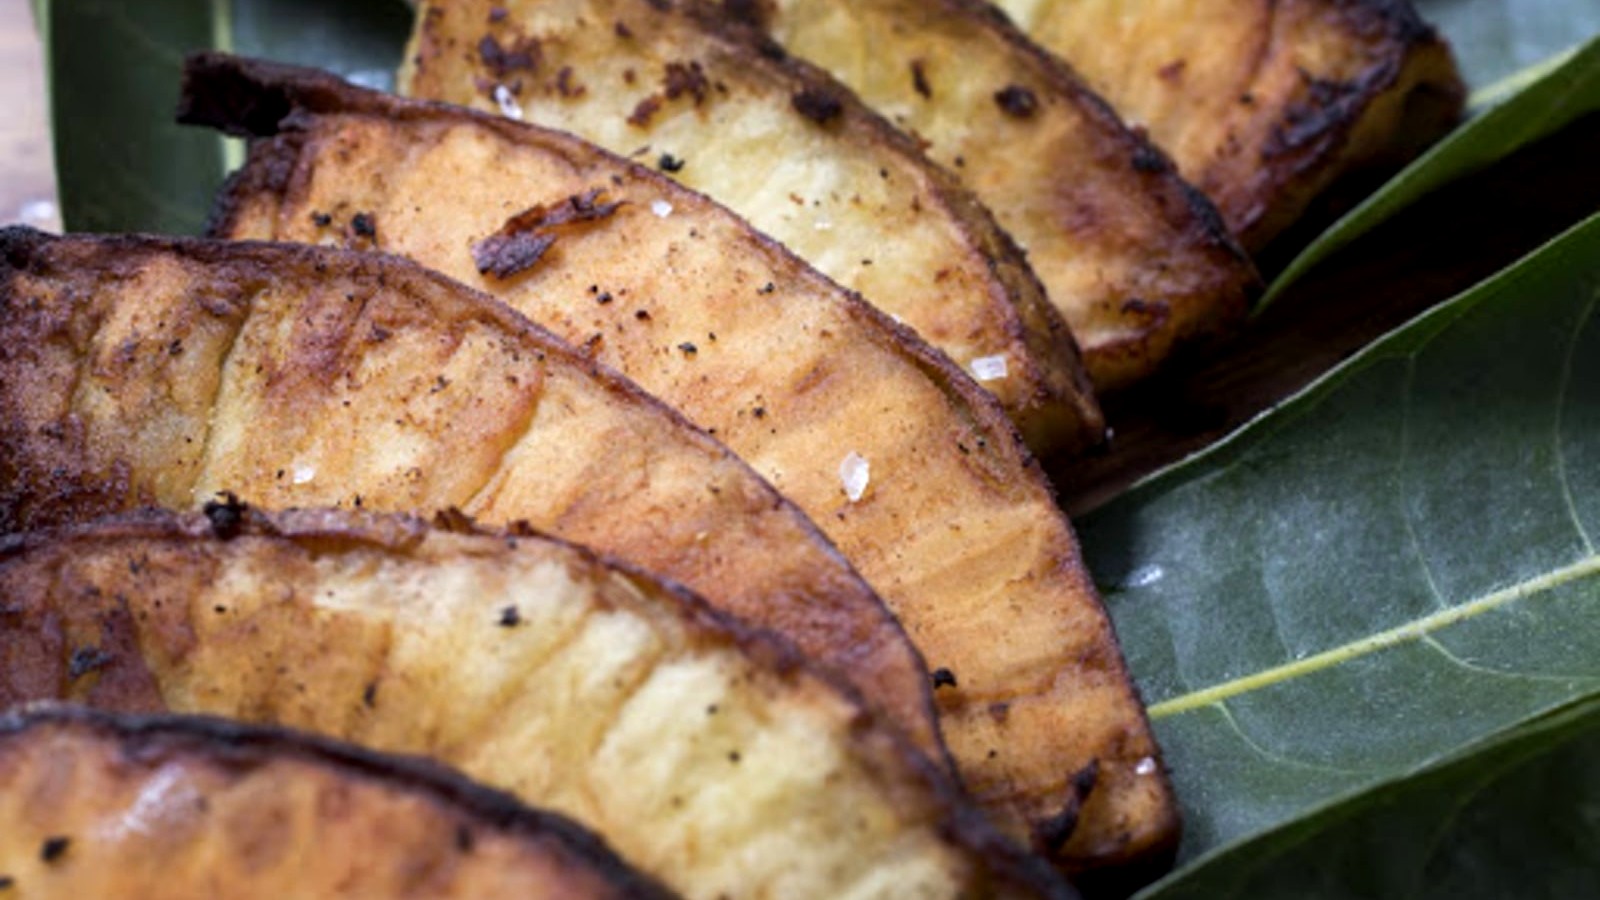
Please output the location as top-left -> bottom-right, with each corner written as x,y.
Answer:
1141,701 -> 1600,900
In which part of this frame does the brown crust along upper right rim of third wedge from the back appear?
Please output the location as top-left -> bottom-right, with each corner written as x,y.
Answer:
400,0 -> 1106,453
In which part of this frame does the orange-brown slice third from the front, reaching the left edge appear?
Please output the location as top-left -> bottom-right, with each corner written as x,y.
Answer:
0,229 -> 946,759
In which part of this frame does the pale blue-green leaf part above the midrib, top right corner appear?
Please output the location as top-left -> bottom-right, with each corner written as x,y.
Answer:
1416,0 -> 1600,91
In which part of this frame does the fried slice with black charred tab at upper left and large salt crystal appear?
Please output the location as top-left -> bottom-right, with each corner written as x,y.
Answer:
184,58 -> 1176,871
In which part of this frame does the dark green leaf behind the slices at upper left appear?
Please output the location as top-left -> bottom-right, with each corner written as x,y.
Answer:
44,0 -> 410,234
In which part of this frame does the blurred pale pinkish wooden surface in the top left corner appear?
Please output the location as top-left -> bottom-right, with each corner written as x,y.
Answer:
0,0 -> 61,231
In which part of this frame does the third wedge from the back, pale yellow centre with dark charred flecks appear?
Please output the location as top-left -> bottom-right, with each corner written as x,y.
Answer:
400,0 -> 1106,452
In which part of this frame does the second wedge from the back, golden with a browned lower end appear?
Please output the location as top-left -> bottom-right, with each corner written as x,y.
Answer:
709,0 -> 1258,392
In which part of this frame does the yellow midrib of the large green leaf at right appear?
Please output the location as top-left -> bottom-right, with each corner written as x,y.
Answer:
1149,554 -> 1600,719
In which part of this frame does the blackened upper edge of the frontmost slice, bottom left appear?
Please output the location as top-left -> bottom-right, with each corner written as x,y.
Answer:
0,705 -> 675,900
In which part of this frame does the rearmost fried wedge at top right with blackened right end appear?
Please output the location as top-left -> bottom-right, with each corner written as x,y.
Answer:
998,0 -> 1466,250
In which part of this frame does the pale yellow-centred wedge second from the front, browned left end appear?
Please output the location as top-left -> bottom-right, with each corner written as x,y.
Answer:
0,504 -> 1070,898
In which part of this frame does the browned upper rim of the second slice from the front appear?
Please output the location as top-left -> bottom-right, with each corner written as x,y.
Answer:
0,509 -> 1077,900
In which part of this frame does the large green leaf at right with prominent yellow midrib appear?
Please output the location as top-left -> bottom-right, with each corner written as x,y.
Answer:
1080,209 -> 1600,860
